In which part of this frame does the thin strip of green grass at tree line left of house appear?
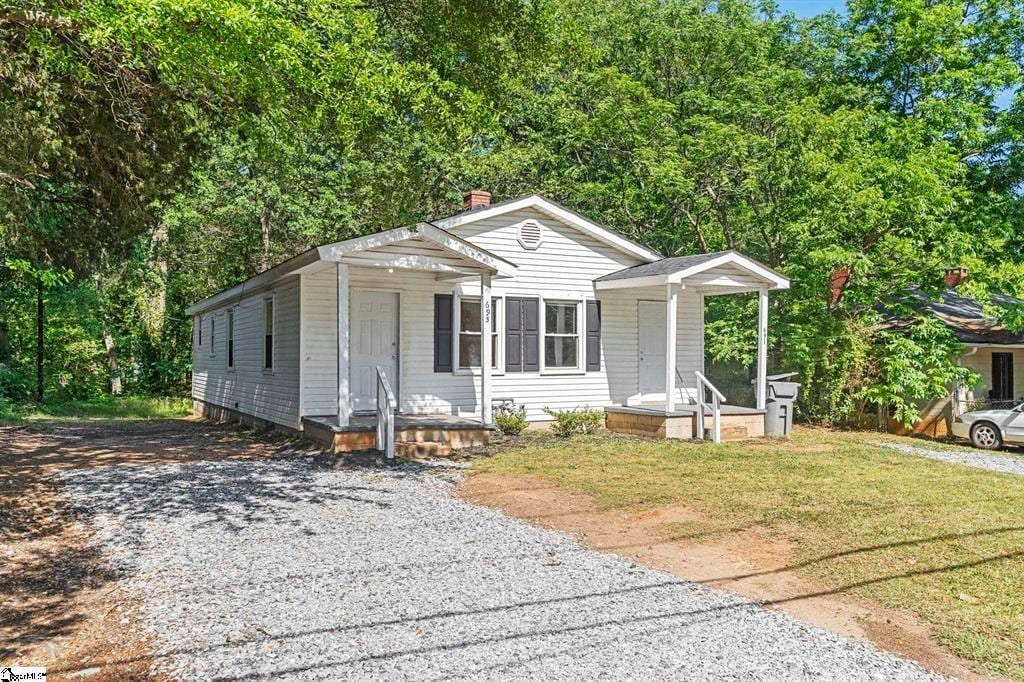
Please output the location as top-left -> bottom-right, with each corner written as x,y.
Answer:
0,397 -> 191,424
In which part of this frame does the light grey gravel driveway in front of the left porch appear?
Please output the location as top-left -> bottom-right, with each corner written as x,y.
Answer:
63,458 -> 939,680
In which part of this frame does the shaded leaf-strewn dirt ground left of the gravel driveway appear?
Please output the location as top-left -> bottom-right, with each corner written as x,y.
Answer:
0,420 -> 311,680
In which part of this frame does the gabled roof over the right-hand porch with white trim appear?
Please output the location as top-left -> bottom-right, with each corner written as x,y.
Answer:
594,251 -> 790,293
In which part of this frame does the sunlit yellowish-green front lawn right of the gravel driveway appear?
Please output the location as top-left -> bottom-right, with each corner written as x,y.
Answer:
474,429 -> 1024,680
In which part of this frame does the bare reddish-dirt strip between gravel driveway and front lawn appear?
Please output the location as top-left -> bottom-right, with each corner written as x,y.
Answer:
460,474 -> 993,680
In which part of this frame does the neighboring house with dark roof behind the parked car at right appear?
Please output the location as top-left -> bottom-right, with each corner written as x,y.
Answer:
890,268 -> 1024,437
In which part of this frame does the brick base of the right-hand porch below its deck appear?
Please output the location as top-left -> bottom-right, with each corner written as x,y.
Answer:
604,406 -> 765,440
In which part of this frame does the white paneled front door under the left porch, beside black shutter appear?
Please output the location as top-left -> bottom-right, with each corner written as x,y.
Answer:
349,289 -> 398,411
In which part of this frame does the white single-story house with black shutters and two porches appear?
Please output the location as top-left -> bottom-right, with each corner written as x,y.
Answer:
187,191 -> 788,449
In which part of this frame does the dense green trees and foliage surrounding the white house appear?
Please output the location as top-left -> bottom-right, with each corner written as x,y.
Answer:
0,0 -> 1024,423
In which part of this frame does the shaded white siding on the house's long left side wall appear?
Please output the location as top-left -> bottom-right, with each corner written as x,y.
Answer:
193,275 -> 299,428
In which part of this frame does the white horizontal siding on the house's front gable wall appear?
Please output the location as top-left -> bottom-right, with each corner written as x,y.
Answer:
303,210 -> 651,421
